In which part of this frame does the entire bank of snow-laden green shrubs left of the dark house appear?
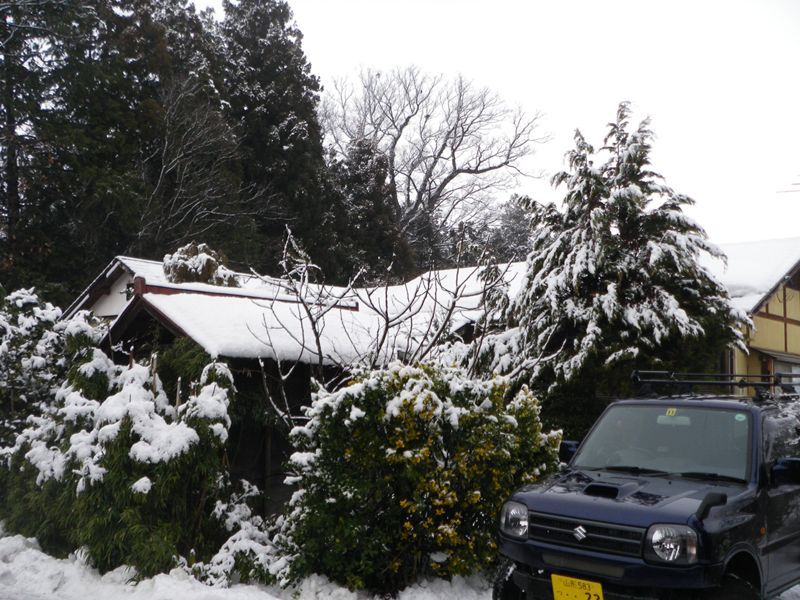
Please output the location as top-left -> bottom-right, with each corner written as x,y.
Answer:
0,300 -> 276,585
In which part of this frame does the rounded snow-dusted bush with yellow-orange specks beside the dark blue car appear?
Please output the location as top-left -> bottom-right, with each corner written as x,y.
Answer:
282,363 -> 560,592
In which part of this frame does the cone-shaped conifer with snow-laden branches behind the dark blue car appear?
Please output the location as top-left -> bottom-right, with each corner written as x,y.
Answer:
511,103 -> 747,396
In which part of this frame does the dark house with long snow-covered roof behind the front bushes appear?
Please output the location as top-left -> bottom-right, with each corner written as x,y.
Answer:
65,256 -> 512,500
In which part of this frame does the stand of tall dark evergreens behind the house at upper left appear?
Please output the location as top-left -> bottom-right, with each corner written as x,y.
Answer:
0,0 -> 400,303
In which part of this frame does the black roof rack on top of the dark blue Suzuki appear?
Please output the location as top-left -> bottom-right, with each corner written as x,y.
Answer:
631,370 -> 800,400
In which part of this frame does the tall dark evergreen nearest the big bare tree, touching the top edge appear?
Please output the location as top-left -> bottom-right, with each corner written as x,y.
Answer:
217,0 -> 337,272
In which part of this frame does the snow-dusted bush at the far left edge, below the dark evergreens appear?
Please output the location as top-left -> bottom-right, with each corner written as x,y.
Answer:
0,304 -> 108,553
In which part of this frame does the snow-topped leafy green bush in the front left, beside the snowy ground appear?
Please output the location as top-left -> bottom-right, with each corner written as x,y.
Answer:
0,348 -> 272,576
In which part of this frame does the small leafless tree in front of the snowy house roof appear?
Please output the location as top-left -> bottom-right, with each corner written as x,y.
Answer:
251,227 -> 509,429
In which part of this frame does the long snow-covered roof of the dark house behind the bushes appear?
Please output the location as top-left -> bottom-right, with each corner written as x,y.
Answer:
106,258 -> 525,364
